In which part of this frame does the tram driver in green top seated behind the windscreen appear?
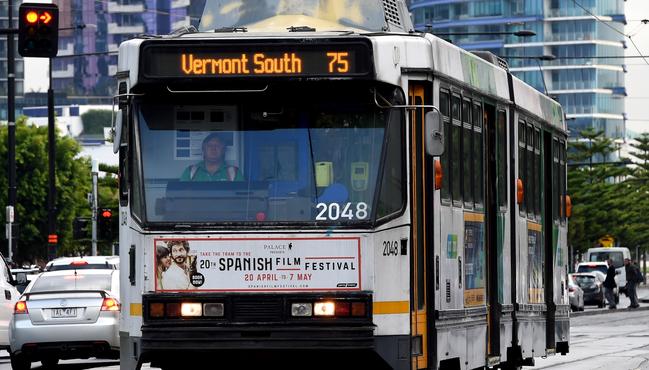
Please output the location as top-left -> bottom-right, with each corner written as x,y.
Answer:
180,132 -> 244,181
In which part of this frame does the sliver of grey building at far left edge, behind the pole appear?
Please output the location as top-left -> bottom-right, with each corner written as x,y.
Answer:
0,1 -> 25,121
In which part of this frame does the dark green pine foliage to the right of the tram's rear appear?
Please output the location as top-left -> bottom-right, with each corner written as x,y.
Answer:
568,130 -> 649,251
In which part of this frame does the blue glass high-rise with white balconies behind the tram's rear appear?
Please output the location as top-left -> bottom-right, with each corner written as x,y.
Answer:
410,0 -> 628,138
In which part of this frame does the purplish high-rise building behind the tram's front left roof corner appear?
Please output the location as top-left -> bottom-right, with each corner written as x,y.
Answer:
52,0 -> 204,104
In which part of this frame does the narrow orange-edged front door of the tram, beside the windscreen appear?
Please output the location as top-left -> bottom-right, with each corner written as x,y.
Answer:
409,82 -> 434,369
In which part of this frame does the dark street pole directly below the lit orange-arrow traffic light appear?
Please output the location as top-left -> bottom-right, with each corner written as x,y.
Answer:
47,58 -> 58,259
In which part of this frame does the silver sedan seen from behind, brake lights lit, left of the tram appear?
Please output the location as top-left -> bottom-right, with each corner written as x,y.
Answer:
9,269 -> 120,370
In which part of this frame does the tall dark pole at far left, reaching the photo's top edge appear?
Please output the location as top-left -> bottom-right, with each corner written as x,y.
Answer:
7,0 -> 18,255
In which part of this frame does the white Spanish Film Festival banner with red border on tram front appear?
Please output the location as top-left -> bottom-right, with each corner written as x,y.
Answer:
154,238 -> 361,292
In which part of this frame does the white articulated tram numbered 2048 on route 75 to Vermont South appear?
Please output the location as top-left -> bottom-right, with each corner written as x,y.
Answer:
114,0 -> 570,369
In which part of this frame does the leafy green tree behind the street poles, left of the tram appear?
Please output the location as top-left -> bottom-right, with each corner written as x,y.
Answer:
0,117 -> 91,261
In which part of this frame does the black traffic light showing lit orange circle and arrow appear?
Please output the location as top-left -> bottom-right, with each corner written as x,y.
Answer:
18,3 -> 59,58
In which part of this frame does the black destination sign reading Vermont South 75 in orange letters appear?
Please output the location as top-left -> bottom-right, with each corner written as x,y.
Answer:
140,41 -> 372,79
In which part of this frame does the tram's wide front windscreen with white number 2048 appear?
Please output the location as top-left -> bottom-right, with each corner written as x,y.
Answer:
134,87 -> 402,224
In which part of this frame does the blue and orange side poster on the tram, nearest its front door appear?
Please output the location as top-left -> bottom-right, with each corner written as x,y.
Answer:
464,221 -> 486,307
